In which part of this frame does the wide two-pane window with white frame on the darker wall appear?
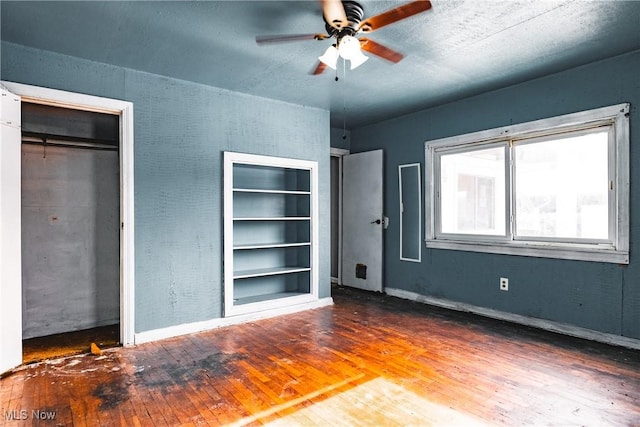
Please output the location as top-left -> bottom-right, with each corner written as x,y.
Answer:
425,104 -> 629,264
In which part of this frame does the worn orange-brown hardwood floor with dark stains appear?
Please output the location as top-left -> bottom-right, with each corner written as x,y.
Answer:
0,289 -> 640,427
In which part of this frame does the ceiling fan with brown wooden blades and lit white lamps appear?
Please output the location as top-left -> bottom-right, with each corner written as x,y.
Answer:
256,0 -> 431,75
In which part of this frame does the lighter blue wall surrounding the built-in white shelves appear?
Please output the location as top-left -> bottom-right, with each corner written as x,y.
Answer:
5,43 -> 331,332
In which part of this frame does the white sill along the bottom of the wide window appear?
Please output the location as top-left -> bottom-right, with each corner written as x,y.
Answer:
426,240 -> 629,264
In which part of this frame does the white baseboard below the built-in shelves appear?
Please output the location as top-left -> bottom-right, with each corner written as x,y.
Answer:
135,297 -> 333,344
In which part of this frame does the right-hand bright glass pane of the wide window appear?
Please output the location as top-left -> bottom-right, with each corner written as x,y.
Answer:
514,130 -> 609,240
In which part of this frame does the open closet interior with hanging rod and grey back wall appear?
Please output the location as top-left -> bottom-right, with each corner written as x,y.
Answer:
21,102 -> 121,363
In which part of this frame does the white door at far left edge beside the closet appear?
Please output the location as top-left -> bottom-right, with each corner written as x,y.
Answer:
0,87 -> 22,374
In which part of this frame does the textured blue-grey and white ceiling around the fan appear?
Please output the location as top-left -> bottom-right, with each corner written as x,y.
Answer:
0,0 -> 640,128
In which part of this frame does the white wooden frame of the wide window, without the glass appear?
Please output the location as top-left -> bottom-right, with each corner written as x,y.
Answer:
425,103 -> 629,264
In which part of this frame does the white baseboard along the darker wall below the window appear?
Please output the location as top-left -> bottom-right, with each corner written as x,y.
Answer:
385,288 -> 640,350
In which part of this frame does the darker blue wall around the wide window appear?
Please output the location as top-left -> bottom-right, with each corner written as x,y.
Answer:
351,51 -> 640,339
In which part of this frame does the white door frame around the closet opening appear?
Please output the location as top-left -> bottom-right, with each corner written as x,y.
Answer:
0,81 -> 135,347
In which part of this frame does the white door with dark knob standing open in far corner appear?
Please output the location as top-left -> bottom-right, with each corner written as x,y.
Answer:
342,150 -> 384,292
